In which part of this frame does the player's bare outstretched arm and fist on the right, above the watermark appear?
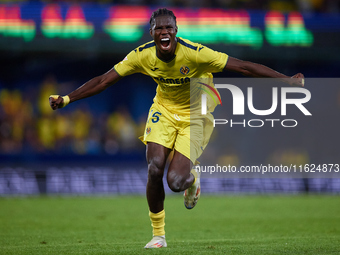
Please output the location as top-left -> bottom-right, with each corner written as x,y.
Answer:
225,56 -> 304,86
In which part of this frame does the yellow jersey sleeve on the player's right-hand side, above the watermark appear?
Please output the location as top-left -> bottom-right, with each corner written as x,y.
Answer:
196,46 -> 228,73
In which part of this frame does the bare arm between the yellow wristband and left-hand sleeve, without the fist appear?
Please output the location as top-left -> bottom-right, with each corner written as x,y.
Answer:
68,70 -> 121,103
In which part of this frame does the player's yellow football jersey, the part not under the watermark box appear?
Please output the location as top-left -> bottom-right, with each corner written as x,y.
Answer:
114,37 -> 228,115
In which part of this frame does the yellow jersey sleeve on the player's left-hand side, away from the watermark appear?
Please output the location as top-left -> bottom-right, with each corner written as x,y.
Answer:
113,50 -> 141,77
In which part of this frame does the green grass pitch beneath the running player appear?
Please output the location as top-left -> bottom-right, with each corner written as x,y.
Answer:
0,195 -> 340,255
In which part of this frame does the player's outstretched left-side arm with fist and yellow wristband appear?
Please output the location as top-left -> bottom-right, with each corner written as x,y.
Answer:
49,68 -> 121,110
